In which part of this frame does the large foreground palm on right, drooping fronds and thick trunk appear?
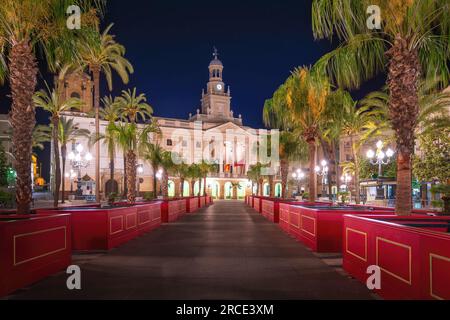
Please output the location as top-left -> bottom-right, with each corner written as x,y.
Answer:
312,0 -> 450,215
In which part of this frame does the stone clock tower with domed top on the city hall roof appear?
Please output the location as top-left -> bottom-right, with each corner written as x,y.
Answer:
201,48 -> 233,121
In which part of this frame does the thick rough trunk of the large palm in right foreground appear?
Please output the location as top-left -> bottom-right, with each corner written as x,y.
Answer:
387,36 -> 421,215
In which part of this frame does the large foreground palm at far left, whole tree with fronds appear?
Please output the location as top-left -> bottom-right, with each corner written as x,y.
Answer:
0,0 -> 105,213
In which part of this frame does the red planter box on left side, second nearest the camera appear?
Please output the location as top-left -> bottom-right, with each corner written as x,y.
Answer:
40,201 -> 161,250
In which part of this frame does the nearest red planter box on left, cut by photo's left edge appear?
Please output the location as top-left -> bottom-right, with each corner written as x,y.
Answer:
0,214 -> 72,297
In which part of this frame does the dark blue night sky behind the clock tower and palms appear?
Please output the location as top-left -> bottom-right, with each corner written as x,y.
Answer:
0,0 -> 383,180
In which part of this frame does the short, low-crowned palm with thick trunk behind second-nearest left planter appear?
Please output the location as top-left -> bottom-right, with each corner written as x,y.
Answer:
112,122 -> 154,204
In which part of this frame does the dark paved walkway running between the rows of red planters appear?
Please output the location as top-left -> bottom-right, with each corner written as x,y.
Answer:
9,201 -> 372,299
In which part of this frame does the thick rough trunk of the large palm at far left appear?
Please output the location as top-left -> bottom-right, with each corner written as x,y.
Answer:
9,40 -> 38,214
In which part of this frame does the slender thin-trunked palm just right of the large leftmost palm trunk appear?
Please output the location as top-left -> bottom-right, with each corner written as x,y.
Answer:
33,87 -> 83,208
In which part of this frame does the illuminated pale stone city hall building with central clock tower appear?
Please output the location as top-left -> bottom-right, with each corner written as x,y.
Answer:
56,53 -> 281,199
